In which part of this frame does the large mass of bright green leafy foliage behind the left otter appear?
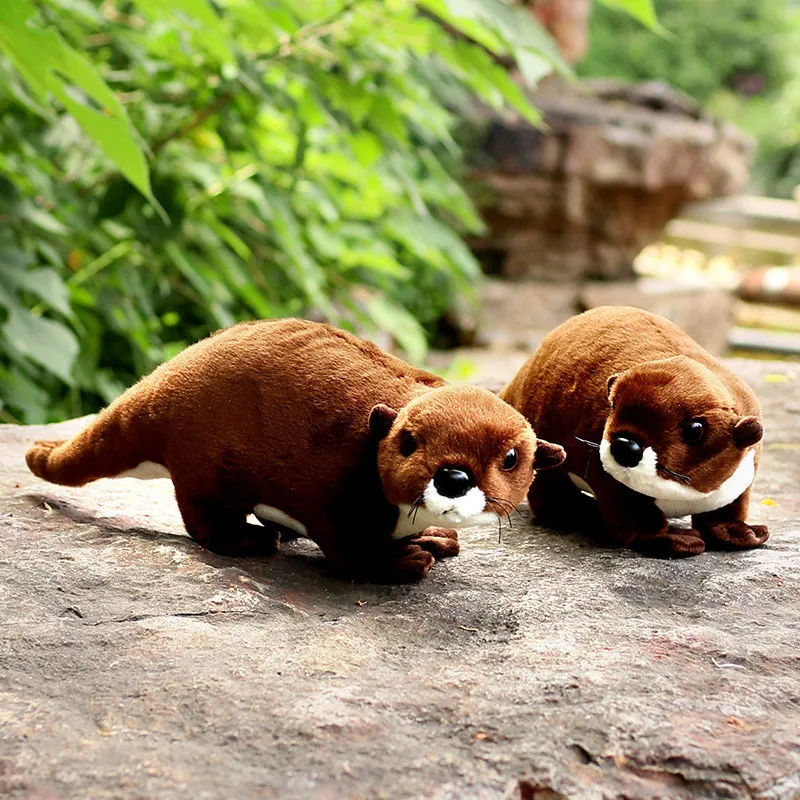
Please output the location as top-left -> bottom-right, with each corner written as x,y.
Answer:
0,0 -> 566,422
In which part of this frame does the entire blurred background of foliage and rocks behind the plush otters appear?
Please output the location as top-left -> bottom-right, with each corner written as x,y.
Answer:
0,0 -> 800,423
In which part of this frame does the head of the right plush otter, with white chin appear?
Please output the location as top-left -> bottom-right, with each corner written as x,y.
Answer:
600,356 -> 763,501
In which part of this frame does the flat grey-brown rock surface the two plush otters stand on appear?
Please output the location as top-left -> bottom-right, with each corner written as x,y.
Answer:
0,362 -> 800,800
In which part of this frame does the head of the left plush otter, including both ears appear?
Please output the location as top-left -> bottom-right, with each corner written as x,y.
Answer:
369,386 -> 564,535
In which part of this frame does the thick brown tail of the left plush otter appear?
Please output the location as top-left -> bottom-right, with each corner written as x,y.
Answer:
25,396 -> 157,486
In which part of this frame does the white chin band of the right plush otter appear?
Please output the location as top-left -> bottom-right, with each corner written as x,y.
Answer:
592,439 -> 756,519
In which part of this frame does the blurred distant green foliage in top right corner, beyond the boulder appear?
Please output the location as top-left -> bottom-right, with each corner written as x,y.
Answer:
578,0 -> 800,195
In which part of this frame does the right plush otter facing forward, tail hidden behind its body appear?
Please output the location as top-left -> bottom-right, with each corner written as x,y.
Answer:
500,307 -> 769,556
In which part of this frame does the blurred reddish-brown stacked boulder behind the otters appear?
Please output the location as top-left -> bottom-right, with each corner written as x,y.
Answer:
470,78 -> 752,281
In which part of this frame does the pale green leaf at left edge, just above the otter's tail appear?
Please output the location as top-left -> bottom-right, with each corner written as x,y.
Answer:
3,307 -> 78,385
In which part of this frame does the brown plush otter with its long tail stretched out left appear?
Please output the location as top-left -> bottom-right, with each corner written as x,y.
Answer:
27,319 -> 564,582
